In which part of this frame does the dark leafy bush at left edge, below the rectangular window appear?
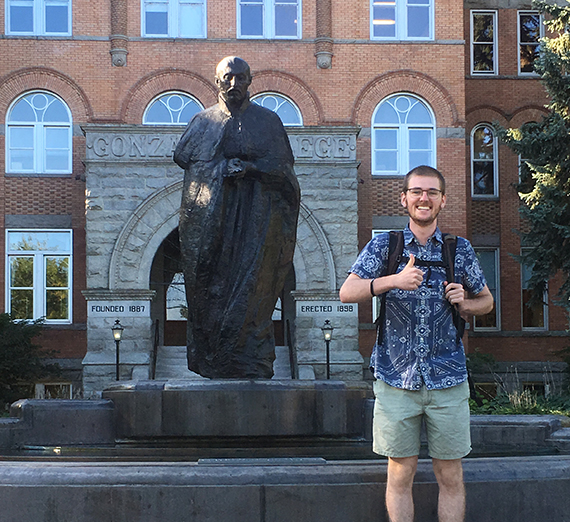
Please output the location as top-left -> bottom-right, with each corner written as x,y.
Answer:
0,314 -> 59,404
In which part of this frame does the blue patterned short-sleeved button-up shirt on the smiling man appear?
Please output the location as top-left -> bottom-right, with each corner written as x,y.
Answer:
350,227 -> 486,390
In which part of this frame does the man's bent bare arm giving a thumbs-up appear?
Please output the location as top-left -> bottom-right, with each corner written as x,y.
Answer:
339,254 -> 424,303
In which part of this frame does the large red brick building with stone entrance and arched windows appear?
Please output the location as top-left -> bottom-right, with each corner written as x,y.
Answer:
0,0 -> 566,395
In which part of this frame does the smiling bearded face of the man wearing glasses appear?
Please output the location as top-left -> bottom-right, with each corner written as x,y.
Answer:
401,176 -> 446,226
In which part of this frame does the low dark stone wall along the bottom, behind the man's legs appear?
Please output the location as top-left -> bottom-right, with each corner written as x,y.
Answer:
0,456 -> 570,522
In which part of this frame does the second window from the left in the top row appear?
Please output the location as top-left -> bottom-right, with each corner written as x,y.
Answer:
141,0 -> 206,38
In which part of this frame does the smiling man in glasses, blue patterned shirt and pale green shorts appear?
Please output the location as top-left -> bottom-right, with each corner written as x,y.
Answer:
340,166 -> 493,522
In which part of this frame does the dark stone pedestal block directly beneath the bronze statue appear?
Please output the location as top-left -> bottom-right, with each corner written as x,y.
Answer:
103,380 -> 371,440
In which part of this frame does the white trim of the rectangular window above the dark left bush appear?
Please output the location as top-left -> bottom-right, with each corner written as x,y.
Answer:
4,228 -> 73,324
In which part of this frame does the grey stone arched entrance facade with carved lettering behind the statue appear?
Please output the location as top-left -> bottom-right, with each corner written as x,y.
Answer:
83,125 -> 362,396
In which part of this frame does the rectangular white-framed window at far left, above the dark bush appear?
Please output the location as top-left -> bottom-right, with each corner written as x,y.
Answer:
6,230 -> 71,323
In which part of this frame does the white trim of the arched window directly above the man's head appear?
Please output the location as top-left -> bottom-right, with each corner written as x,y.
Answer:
370,92 -> 437,177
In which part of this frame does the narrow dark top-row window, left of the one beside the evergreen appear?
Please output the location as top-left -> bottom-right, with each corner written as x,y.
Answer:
471,11 -> 497,74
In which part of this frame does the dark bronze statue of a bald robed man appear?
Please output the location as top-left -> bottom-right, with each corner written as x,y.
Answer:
174,56 -> 300,378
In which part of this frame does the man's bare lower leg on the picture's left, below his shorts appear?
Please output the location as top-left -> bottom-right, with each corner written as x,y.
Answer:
386,456 -> 418,522
